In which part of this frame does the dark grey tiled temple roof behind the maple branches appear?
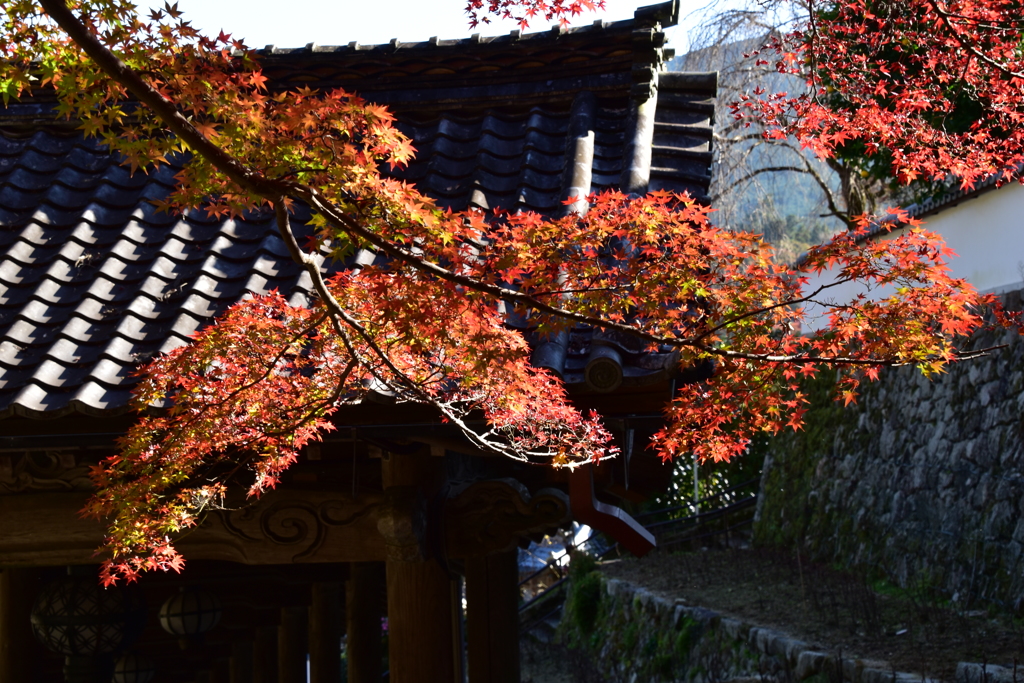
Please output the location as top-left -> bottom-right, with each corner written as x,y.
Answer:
0,6 -> 715,417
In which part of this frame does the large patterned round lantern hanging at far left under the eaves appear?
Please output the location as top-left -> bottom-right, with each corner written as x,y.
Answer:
32,575 -> 145,657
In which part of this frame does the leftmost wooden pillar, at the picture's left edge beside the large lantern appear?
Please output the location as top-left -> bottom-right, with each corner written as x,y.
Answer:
0,569 -> 39,683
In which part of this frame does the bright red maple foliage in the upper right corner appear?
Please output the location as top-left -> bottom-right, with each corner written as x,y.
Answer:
734,0 -> 1024,187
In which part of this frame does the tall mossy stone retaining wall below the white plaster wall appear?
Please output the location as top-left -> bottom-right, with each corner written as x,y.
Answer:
755,321 -> 1024,614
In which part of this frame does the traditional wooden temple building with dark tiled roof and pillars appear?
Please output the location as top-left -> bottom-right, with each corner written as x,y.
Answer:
0,2 -> 716,683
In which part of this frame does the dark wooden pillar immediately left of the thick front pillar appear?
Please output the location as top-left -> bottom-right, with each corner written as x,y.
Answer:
345,562 -> 384,683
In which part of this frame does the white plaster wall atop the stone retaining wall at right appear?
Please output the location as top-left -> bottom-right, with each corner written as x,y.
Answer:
804,182 -> 1024,329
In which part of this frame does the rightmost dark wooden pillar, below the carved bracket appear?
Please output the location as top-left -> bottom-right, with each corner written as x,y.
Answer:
466,550 -> 519,683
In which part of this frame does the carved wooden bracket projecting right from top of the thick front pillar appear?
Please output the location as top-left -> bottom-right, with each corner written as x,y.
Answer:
442,479 -> 571,558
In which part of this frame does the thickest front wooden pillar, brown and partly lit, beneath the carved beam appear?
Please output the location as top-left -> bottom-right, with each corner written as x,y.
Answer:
383,454 -> 459,683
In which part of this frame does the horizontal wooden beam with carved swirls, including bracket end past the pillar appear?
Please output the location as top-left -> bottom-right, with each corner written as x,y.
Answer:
0,479 -> 569,566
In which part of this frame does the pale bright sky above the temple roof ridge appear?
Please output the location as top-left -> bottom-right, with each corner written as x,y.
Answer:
163,0 -> 707,52
